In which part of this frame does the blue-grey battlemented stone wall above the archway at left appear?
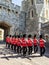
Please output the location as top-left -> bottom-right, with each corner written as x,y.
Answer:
0,1 -> 20,35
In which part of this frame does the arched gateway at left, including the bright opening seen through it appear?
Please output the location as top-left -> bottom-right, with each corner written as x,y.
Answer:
0,22 -> 11,41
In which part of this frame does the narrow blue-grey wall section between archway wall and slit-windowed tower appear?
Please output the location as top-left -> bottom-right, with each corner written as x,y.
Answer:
19,11 -> 26,34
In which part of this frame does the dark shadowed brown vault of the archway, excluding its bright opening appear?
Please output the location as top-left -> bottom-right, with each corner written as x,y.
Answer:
0,22 -> 11,41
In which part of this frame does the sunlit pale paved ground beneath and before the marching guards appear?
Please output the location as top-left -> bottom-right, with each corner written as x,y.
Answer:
0,44 -> 49,65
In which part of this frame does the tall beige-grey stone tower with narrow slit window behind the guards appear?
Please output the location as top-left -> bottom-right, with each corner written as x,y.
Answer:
22,0 -> 38,35
